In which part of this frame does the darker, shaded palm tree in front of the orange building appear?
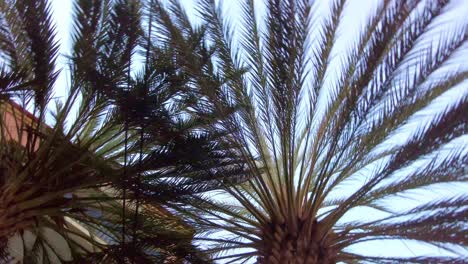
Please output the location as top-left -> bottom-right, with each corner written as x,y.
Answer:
0,0 -> 245,263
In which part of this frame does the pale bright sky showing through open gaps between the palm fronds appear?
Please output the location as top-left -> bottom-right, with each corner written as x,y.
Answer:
52,0 -> 468,262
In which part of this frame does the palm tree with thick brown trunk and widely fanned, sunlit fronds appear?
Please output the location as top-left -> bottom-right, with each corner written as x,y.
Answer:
153,0 -> 468,264
